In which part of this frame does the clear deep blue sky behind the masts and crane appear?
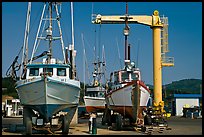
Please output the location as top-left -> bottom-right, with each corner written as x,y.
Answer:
2,2 -> 202,84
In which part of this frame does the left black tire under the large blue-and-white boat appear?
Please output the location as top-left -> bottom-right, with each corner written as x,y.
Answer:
23,108 -> 32,135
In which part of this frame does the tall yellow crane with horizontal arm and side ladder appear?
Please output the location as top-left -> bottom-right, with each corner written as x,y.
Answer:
92,10 -> 174,122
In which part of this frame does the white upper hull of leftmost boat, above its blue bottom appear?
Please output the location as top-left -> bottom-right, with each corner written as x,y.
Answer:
16,77 -> 80,105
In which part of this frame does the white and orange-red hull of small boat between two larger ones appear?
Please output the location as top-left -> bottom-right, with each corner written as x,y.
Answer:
84,96 -> 106,113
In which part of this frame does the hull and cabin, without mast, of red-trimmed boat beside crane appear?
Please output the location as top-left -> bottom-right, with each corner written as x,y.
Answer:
105,63 -> 150,125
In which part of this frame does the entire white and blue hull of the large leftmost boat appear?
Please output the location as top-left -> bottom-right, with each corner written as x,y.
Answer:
16,77 -> 80,120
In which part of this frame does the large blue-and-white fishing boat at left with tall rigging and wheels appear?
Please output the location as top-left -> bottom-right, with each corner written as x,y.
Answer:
8,2 -> 80,134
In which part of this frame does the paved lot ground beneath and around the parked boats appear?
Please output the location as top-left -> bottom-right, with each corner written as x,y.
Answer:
2,116 -> 202,135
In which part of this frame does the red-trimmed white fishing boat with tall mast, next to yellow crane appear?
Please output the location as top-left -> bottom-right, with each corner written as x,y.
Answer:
99,5 -> 151,130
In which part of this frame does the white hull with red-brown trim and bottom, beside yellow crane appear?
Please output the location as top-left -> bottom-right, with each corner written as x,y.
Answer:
106,81 -> 150,123
